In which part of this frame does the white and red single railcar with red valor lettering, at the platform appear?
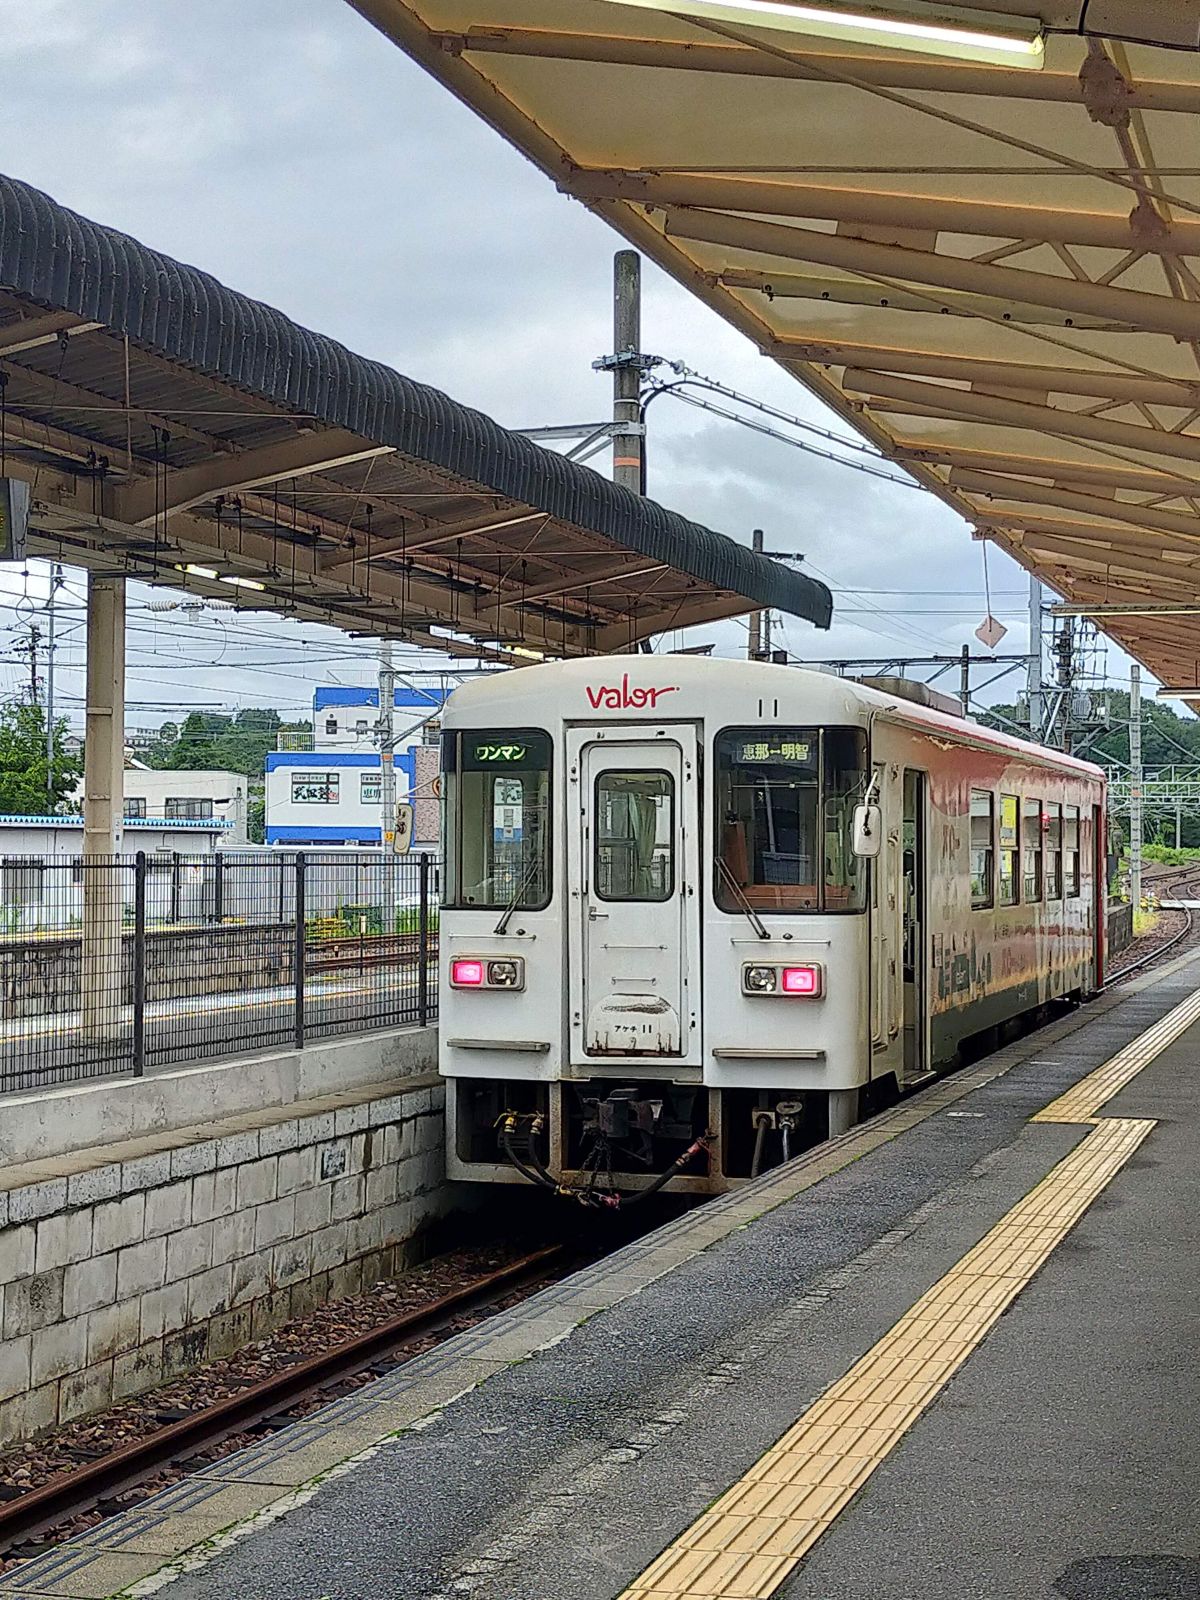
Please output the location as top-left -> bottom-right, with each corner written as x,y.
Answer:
440,654 -> 1104,1194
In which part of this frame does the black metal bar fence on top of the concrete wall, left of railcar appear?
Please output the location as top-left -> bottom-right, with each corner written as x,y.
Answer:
0,850 -> 440,1093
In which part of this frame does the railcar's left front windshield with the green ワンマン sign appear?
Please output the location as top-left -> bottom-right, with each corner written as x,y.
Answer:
442,728 -> 550,910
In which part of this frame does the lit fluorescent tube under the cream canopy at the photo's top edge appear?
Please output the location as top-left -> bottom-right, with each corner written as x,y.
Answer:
614,0 -> 1045,67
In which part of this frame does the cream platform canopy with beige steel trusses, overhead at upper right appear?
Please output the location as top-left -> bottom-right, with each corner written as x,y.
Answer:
350,0 -> 1200,686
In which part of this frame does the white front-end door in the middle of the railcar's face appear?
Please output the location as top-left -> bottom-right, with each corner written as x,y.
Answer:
566,725 -> 701,1067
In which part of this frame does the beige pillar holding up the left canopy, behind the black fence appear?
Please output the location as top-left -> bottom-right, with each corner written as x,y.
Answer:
80,573 -> 133,1040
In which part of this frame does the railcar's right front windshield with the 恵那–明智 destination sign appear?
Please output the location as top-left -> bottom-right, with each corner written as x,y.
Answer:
714,728 -> 867,912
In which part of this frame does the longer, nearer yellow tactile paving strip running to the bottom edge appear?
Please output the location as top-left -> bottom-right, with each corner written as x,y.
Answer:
621,1113 -> 1163,1600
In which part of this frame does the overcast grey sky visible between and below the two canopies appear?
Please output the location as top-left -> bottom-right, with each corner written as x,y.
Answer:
0,0 -> 1126,725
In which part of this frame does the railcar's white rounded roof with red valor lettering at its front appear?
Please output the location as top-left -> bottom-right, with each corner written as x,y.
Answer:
445,654 -> 1104,781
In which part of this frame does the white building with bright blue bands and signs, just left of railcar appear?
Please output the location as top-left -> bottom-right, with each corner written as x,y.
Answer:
266,688 -> 446,850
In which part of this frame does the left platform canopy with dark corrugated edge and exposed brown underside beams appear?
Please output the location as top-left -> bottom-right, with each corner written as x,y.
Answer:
0,178 -> 830,661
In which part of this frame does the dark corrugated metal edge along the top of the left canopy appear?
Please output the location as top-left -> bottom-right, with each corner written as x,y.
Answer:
0,176 -> 832,627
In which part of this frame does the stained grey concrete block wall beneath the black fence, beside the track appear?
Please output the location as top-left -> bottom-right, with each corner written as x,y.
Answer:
0,1075 -> 445,1446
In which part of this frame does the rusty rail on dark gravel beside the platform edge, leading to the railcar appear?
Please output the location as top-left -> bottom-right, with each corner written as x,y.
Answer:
0,1245 -> 576,1555
